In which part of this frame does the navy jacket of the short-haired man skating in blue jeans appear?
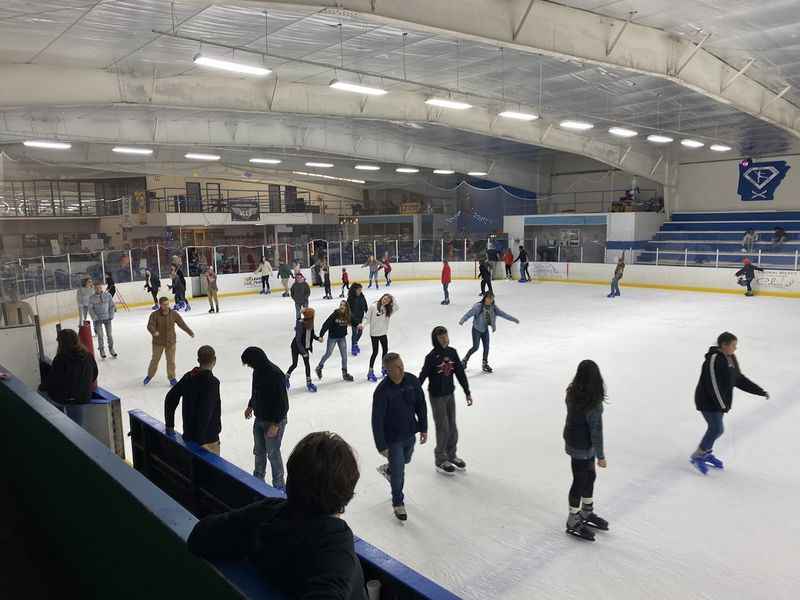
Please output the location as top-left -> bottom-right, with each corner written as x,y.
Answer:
372,373 -> 428,452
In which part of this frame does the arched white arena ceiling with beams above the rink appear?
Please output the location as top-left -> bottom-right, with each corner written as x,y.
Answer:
0,0 -> 800,189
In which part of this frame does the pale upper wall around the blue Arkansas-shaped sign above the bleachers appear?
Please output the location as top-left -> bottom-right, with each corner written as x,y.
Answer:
672,156 -> 800,212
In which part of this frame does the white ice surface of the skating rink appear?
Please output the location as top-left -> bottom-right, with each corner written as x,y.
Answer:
46,281 -> 800,600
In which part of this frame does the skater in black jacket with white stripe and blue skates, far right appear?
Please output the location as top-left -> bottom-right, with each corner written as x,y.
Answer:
689,331 -> 769,475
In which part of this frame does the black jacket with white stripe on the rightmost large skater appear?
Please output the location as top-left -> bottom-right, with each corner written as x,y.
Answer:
694,346 -> 767,413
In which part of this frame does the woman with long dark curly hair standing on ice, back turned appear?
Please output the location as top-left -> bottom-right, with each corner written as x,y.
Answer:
564,360 -> 608,542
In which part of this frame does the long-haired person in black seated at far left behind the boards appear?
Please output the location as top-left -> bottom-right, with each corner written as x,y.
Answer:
42,329 -> 98,404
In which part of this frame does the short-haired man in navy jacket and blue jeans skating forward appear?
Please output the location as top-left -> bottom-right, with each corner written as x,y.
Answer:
372,352 -> 428,521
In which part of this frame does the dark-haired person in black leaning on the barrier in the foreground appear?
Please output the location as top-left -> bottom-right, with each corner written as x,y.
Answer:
187,431 -> 367,600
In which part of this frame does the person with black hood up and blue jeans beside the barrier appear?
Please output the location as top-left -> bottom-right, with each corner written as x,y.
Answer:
242,346 -> 289,490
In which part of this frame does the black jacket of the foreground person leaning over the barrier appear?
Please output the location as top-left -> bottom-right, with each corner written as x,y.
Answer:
188,498 -> 367,600
